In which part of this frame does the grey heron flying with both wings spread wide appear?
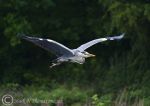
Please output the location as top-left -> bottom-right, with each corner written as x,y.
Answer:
19,33 -> 124,68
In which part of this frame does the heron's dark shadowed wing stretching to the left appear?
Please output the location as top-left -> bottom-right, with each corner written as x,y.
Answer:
19,34 -> 73,56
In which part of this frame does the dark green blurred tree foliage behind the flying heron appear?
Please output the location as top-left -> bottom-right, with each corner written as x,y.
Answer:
0,0 -> 150,105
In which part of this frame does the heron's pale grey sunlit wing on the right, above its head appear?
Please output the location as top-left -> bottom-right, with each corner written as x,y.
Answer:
77,33 -> 124,52
